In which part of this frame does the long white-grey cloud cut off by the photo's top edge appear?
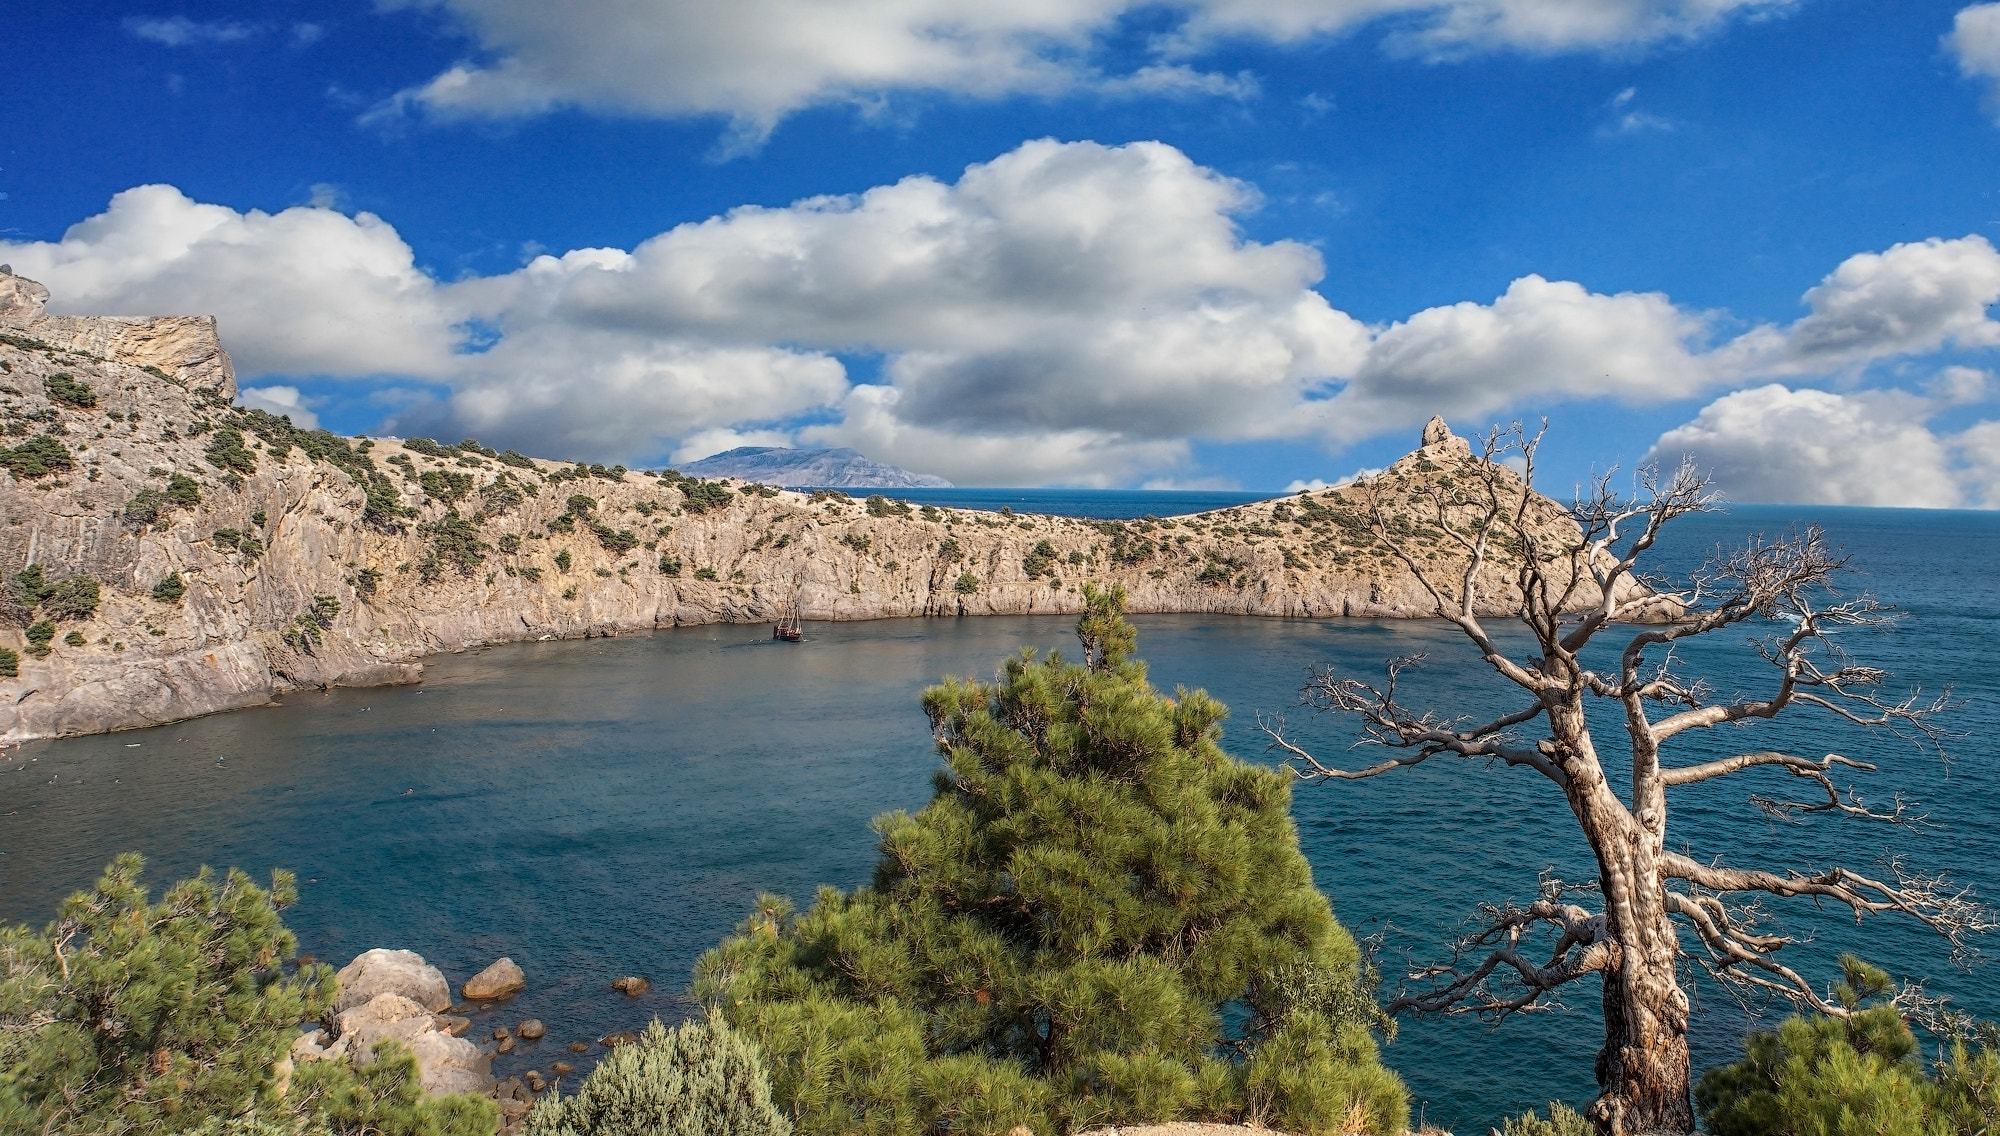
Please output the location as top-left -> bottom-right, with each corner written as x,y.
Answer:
376,0 -> 1794,140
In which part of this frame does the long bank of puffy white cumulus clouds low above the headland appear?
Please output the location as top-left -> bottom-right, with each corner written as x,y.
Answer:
15,140 -> 2000,492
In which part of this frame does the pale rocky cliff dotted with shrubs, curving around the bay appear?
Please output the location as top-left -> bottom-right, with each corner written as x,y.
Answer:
0,288 -> 1640,740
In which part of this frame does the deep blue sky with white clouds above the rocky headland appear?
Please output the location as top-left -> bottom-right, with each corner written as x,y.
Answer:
0,0 -> 2000,506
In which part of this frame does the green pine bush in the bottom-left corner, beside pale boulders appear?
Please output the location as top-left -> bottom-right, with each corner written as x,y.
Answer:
0,854 -> 498,1136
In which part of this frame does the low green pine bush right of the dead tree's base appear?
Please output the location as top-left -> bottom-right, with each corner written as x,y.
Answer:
1694,956 -> 2000,1136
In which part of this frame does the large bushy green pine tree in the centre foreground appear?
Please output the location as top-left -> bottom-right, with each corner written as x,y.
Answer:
696,588 -> 1408,1136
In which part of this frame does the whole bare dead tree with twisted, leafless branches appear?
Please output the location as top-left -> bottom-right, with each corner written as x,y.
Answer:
1264,424 -> 1994,1134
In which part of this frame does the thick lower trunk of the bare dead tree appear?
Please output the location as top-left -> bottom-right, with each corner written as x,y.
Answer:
1590,814 -> 1694,1136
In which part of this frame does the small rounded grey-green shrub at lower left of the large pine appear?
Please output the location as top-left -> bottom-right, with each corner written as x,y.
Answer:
522,1014 -> 792,1136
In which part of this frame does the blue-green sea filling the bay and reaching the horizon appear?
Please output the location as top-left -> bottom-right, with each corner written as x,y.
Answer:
0,490 -> 2000,1134
